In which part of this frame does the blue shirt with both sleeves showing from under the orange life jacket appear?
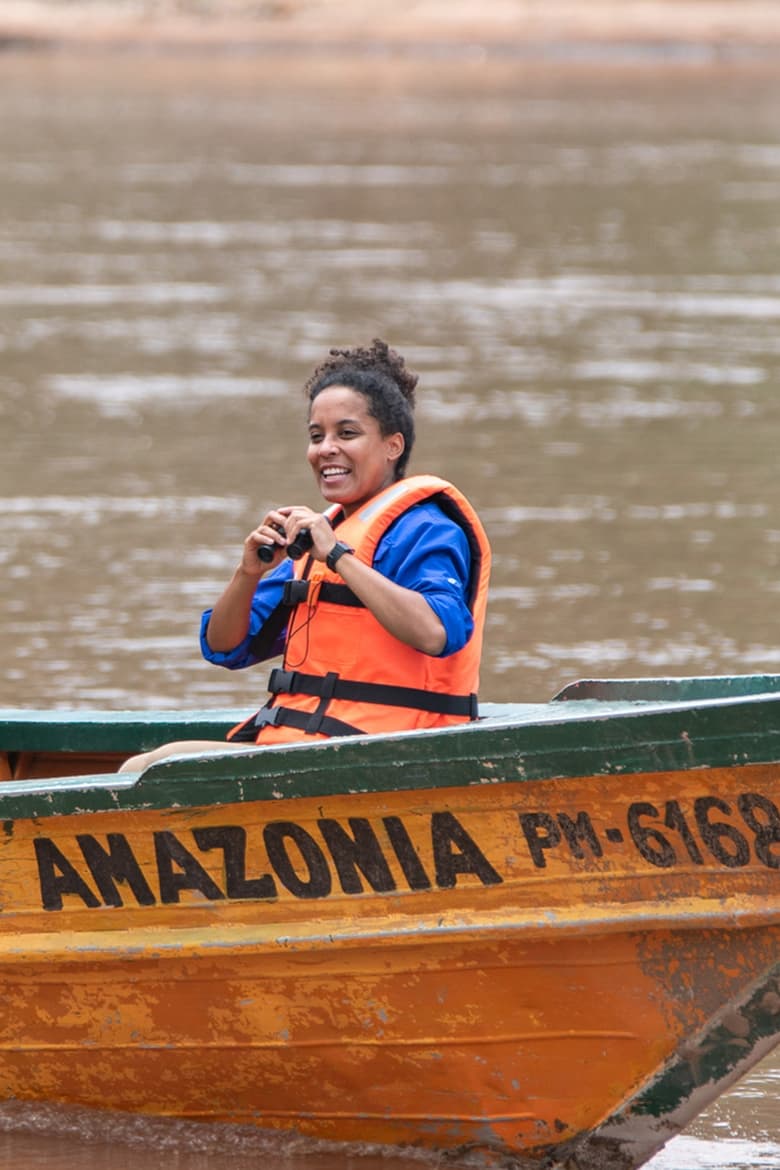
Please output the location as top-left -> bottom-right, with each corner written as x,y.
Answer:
200,501 -> 474,670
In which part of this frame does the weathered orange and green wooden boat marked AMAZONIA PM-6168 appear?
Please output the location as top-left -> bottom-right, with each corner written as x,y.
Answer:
0,675 -> 780,1170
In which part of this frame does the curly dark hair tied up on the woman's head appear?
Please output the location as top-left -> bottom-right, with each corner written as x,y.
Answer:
304,338 -> 419,480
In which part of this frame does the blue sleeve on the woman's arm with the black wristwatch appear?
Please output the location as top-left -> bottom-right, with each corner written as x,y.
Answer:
374,502 -> 474,658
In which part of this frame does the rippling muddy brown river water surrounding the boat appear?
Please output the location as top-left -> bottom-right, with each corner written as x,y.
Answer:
0,45 -> 780,1170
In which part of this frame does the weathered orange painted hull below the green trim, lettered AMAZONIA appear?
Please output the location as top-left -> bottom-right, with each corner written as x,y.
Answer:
0,748 -> 780,1170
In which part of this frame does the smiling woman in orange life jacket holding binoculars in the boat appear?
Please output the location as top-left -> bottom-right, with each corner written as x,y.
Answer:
123,340 -> 490,770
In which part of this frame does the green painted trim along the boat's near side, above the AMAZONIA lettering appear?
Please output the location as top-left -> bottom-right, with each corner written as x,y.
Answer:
0,694 -> 780,820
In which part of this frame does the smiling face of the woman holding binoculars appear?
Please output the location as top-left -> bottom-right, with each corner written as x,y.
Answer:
306,386 -> 403,516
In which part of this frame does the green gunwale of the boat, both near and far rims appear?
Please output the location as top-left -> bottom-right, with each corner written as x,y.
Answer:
0,675 -> 780,821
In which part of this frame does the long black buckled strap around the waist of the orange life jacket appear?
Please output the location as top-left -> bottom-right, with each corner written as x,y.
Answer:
268,667 -> 478,720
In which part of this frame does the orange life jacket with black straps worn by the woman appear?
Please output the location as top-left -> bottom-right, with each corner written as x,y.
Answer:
228,475 -> 490,743
